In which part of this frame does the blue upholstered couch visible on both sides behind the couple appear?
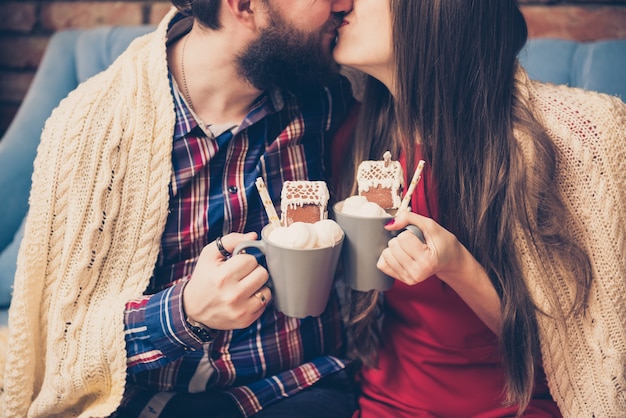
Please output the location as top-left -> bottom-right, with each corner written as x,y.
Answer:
0,26 -> 626,325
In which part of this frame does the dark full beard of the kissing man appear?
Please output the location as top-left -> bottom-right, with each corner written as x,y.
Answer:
237,15 -> 339,90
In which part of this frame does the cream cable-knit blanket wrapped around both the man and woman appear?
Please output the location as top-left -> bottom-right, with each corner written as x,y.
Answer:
3,9 -> 626,418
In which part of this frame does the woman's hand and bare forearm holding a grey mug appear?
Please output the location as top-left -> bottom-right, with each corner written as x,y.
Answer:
376,212 -> 501,335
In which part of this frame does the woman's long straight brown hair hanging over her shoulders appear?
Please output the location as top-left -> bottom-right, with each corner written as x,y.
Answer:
338,0 -> 591,413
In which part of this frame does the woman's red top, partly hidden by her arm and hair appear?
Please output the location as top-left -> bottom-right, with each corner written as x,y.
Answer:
355,153 -> 561,418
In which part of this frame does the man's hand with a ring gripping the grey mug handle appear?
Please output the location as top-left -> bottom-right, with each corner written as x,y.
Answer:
183,232 -> 272,330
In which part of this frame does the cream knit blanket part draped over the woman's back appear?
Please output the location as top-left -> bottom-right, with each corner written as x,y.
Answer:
517,71 -> 626,418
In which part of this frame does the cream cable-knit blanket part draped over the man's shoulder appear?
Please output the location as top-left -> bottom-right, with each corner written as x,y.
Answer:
3,10 -> 175,417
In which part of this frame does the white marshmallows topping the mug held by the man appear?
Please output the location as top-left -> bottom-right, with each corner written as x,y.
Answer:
267,219 -> 343,249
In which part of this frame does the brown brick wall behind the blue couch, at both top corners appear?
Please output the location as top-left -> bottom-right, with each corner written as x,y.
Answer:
0,0 -> 626,140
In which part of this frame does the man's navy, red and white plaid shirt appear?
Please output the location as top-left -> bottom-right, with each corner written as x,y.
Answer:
117,73 -> 352,416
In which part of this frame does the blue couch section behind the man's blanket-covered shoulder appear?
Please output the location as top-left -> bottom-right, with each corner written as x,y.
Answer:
0,26 -> 154,325
